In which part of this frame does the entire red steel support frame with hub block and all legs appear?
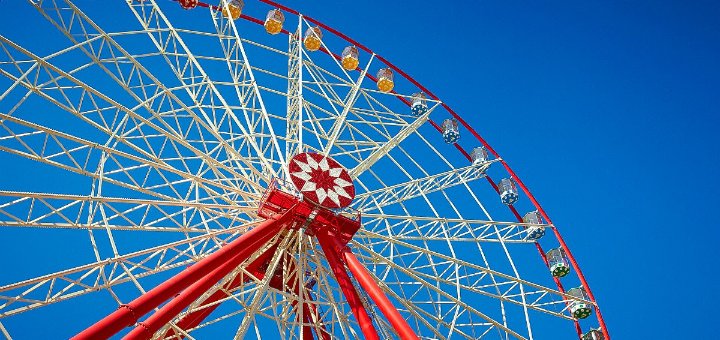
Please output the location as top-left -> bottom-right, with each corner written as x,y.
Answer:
73,178 -> 418,340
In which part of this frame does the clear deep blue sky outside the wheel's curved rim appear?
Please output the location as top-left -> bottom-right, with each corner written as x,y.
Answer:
0,0 -> 720,339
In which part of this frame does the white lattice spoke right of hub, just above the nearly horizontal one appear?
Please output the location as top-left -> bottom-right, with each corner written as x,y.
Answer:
353,161 -> 493,212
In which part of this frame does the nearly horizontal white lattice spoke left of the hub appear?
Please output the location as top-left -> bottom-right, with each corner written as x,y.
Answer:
0,190 -> 250,233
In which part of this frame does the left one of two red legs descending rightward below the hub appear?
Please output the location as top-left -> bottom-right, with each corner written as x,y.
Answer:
317,232 -> 380,340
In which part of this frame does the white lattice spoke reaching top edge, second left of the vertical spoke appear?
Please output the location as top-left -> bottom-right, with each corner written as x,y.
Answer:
122,0 -> 277,179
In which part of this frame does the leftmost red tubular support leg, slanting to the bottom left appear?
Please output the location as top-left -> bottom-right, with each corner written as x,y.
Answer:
73,208 -> 295,340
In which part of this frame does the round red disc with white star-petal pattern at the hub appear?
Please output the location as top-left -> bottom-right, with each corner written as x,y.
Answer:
288,152 -> 355,208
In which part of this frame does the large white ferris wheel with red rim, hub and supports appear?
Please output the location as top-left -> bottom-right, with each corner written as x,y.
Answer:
0,0 -> 609,340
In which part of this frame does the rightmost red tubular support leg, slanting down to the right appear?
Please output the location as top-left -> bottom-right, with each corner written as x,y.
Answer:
335,242 -> 418,339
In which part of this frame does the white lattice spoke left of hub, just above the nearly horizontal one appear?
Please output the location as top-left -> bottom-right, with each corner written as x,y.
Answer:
0,113 -> 257,204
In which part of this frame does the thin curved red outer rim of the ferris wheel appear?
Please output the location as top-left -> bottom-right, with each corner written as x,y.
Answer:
181,0 -> 610,340
